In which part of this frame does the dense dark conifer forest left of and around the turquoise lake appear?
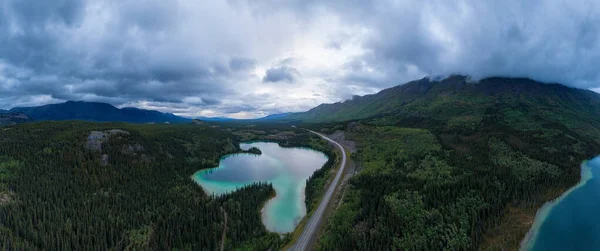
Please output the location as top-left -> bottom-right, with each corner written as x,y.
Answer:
0,121 -> 327,250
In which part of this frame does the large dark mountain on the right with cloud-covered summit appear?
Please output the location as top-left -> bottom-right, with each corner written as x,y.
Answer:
285,75 -> 600,139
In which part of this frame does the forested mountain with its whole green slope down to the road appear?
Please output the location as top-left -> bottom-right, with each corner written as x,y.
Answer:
290,76 -> 600,250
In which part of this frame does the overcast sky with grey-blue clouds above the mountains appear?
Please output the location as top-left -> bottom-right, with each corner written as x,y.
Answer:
0,0 -> 600,118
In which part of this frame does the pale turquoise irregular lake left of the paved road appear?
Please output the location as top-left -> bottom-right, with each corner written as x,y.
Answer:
193,142 -> 327,233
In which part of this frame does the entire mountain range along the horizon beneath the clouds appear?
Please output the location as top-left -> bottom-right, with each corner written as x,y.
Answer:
0,75 -> 600,135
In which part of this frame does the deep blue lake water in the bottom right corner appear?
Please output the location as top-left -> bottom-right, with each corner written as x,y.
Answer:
523,157 -> 600,251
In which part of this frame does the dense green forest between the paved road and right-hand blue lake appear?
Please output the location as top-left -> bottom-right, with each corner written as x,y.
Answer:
313,111 -> 600,250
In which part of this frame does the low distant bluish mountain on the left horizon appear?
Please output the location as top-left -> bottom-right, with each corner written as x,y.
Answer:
9,101 -> 191,123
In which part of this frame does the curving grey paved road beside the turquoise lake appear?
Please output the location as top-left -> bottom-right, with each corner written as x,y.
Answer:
292,130 -> 346,250
